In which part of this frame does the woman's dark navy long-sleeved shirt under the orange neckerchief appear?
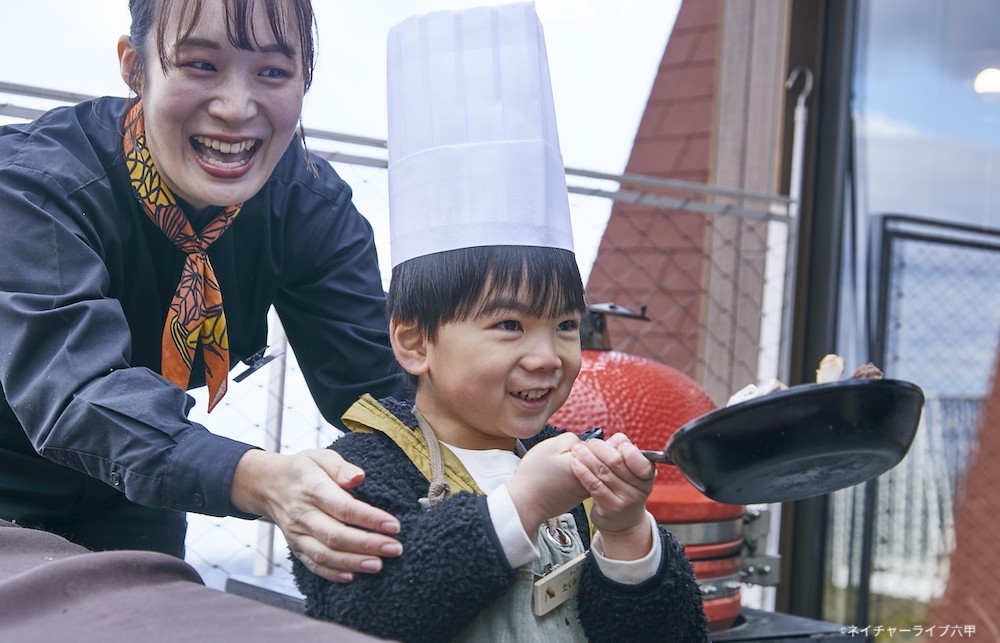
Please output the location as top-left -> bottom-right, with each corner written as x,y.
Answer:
0,98 -> 399,522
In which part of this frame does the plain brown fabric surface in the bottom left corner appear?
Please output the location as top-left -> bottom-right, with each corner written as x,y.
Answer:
0,521 -> 390,643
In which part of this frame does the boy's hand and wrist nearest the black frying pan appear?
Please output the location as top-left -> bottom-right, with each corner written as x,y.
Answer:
571,433 -> 656,560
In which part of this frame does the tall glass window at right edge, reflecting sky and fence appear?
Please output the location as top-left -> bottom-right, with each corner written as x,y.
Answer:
824,0 -> 1000,640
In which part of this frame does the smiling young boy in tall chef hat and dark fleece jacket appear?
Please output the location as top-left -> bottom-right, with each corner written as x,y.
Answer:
292,5 -> 708,641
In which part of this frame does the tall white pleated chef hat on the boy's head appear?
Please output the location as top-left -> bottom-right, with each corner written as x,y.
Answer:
388,3 -> 573,267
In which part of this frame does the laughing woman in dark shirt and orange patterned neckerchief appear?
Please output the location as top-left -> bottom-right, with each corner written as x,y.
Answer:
0,0 -> 401,581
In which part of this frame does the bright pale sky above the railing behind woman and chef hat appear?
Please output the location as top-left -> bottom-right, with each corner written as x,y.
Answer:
0,0 -> 680,173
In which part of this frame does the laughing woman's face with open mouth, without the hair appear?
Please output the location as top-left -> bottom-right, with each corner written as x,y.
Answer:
119,0 -> 305,210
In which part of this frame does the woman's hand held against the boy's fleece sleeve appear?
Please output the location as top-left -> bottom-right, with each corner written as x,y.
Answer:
231,449 -> 403,582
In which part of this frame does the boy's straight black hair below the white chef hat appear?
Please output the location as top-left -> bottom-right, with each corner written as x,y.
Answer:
386,246 -> 587,340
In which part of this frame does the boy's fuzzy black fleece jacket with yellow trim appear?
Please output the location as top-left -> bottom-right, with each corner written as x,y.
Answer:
291,399 -> 708,643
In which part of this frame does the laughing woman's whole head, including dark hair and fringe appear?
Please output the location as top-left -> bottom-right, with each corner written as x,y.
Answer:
118,0 -> 313,209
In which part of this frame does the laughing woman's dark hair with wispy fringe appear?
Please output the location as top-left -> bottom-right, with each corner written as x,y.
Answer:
128,0 -> 316,100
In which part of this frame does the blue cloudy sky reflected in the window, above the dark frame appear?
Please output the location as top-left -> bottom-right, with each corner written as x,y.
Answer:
854,0 -> 1000,228
